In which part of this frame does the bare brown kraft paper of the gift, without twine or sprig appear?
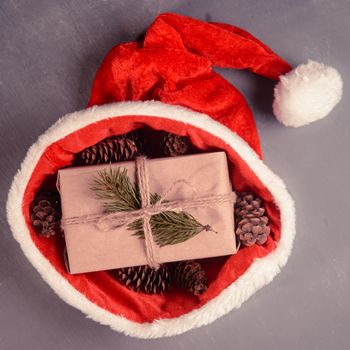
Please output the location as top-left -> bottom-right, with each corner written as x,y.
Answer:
58,152 -> 236,274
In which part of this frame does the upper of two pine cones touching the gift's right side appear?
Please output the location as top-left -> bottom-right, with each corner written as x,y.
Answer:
235,192 -> 265,220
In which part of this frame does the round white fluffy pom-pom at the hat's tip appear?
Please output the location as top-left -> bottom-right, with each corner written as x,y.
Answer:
273,61 -> 343,127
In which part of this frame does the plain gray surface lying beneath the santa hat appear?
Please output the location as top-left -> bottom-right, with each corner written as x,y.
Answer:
0,0 -> 350,350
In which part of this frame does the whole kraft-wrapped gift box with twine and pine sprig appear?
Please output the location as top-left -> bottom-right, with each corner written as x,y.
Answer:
58,152 -> 236,274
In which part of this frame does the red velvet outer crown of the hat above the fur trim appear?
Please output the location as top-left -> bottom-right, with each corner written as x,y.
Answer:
89,13 -> 291,155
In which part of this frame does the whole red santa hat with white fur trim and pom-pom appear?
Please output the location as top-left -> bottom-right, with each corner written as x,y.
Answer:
7,14 -> 342,338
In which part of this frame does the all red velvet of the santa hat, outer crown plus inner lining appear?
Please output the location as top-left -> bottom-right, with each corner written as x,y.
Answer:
23,14 -> 290,323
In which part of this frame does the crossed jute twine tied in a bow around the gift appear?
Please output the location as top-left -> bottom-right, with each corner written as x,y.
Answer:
62,157 -> 234,268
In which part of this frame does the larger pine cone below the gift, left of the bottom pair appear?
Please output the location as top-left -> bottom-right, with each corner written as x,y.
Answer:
116,264 -> 171,294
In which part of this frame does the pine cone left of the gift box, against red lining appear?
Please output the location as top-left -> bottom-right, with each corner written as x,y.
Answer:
30,192 -> 61,237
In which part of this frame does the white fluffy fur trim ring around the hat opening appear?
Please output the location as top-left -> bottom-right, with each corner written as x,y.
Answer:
7,101 -> 295,338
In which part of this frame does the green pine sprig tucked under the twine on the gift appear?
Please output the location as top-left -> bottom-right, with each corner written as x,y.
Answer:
91,168 -> 213,247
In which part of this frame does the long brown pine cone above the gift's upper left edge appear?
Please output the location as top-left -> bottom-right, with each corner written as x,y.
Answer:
79,136 -> 139,165
